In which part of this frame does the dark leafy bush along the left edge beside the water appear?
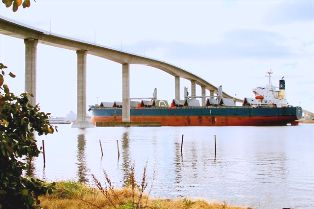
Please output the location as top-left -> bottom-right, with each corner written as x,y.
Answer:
0,63 -> 55,209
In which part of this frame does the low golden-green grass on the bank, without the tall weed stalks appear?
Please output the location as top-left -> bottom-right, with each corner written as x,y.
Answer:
40,182 -> 250,209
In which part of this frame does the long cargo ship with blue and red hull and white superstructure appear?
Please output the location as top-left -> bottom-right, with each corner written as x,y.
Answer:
89,72 -> 302,126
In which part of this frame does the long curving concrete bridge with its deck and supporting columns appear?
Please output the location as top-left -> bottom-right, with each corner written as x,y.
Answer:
0,17 -> 241,128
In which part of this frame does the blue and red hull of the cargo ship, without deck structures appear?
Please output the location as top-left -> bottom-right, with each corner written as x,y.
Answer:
91,107 -> 302,126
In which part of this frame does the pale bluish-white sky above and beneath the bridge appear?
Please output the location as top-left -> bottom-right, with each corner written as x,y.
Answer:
0,0 -> 314,116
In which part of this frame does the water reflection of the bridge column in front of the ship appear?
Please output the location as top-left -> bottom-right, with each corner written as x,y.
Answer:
122,131 -> 130,186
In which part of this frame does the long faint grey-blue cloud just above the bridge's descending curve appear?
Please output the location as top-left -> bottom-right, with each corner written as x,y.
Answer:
122,29 -> 294,59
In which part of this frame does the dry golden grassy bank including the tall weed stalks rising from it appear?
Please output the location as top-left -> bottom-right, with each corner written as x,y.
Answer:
40,165 -> 250,209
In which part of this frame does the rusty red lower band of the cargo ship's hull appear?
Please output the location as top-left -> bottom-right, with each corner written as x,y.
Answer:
92,116 -> 298,126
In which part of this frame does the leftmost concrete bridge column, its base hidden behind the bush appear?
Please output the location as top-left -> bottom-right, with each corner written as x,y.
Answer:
24,39 -> 38,105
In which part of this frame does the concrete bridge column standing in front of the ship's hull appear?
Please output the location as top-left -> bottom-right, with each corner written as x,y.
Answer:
122,63 -> 131,122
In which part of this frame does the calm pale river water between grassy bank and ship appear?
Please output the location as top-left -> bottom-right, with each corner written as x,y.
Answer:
34,125 -> 314,209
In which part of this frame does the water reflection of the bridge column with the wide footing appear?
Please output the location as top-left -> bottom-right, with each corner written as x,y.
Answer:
76,133 -> 88,183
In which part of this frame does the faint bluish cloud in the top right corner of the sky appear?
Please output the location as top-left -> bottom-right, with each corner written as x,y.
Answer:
266,0 -> 314,24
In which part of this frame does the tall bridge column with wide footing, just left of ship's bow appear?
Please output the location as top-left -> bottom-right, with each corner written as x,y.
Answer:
72,50 -> 93,128
